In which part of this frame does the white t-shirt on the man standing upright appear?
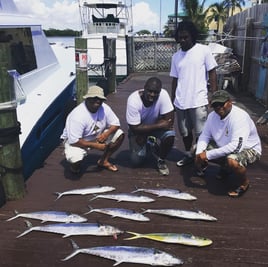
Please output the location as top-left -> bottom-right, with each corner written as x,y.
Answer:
170,43 -> 217,109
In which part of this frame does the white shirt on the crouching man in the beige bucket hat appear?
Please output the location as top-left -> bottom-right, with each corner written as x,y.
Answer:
61,101 -> 120,144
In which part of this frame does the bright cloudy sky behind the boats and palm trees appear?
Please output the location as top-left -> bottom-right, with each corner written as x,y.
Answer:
14,0 -> 249,32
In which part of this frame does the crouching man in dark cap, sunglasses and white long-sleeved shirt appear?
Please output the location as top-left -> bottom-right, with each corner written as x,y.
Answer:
195,90 -> 262,197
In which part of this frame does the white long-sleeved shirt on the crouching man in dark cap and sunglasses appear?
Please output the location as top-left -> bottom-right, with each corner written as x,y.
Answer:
196,105 -> 262,160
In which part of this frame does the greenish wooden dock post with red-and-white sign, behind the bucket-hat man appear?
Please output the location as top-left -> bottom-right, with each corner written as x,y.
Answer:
75,38 -> 88,104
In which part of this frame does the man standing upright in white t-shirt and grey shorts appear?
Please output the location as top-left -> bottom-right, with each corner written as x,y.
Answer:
170,21 -> 217,167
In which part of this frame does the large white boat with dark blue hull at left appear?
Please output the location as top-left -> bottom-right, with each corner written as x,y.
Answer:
0,0 -> 75,179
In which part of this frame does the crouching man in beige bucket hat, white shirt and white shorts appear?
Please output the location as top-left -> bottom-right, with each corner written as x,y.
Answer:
61,85 -> 124,173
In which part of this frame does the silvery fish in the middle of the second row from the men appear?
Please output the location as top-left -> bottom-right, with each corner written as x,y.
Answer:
85,207 -> 150,222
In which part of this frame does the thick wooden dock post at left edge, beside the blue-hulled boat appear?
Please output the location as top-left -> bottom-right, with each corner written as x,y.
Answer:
0,41 -> 25,204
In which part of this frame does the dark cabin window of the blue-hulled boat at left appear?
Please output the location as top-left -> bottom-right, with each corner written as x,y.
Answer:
0,28 -> 37,74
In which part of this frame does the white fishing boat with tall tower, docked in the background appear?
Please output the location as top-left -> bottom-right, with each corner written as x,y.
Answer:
79,0 -> 133,78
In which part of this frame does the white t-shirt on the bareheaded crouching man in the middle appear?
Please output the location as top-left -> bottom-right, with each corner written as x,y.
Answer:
126,89 -> 174,125
